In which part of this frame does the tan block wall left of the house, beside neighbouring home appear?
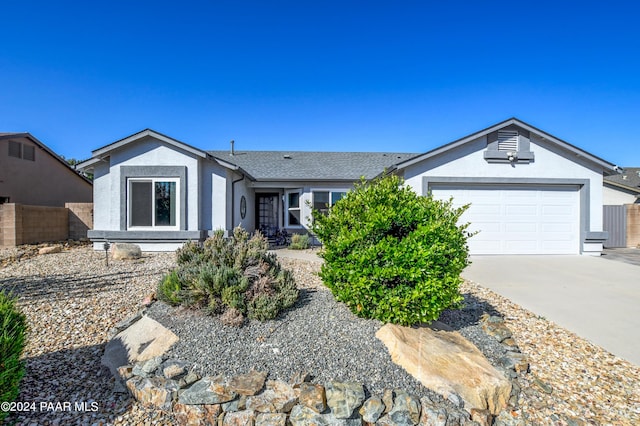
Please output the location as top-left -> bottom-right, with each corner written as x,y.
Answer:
0,203 -> 93,247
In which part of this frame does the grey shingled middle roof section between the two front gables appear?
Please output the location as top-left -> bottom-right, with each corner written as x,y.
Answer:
207,151 -> 417,181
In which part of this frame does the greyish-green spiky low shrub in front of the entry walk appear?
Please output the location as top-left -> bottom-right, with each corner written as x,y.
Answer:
158,228 -> 298,324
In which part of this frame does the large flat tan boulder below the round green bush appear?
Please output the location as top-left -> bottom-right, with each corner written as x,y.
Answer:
378,324 -> 511,414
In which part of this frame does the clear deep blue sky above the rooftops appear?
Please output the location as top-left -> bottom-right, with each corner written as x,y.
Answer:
0,0 -> 640,166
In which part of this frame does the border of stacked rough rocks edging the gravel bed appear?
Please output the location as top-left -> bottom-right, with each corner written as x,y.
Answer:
106,310 -> 552,426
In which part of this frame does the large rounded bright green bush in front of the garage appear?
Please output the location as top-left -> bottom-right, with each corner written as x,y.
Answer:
312,176 -> 469,325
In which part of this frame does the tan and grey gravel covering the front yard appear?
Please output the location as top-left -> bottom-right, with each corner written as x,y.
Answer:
0,246 -> 640,425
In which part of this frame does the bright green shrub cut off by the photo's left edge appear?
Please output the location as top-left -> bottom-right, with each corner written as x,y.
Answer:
0,291 -> 27,421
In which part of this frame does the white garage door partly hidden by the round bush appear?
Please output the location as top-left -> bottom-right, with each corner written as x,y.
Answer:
432,185 -> 580,254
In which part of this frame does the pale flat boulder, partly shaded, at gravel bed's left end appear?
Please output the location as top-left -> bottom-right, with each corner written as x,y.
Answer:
101,316 -> 178,376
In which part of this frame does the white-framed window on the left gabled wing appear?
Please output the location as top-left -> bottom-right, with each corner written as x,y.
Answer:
127,178 -> 180,230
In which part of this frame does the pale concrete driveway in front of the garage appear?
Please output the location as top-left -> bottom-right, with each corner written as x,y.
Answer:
462,256 -> 640,365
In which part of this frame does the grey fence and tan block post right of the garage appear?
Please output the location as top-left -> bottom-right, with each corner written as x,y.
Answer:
602,204 -> 640,248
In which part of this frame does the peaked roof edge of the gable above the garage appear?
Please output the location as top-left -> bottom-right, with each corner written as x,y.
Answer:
394,117 -> 619,174
